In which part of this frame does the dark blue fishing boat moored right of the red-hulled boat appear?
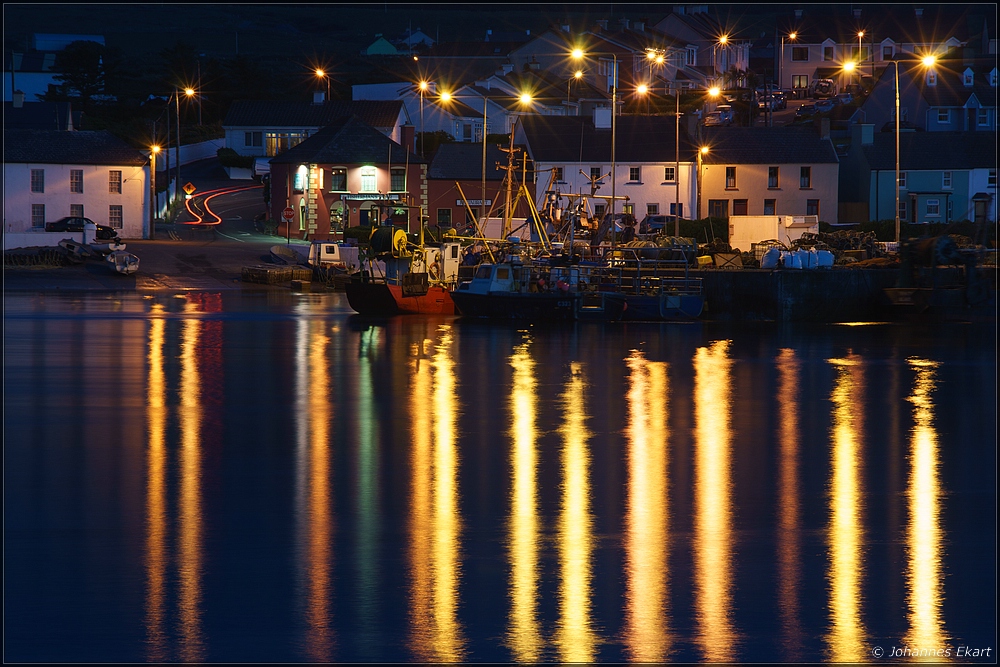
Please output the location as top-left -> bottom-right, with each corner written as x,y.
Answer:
451,255 -> 626,322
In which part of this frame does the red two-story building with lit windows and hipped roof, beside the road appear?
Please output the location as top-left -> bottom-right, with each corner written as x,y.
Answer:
270,116 -> 427,240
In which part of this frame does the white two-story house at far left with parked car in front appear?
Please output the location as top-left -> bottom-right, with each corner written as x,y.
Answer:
3,129 -> 150,248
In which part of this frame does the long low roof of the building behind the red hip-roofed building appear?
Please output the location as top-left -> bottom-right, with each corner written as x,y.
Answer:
222,100 -> 403,128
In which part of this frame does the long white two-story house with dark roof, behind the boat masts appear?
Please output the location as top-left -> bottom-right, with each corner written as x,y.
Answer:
515,114 -> 695,220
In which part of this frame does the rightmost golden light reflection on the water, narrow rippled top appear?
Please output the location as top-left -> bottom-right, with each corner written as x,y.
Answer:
905,358 -> 948,661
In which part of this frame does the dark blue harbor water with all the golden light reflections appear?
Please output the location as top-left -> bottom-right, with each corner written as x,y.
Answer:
4,289 -> 997,663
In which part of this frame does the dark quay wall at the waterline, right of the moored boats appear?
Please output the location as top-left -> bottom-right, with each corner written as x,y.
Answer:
691,269 -> 899,322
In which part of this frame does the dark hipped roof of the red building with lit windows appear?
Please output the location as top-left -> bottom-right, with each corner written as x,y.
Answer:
271,116 -> 426,166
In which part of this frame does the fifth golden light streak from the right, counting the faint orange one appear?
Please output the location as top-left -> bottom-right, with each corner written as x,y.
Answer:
624,351 -> 671,662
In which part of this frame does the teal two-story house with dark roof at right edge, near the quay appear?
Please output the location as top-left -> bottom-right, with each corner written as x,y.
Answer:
843,124 -> 997,223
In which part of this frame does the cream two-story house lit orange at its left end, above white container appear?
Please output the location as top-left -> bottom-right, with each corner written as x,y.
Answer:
697,121 -> 840,223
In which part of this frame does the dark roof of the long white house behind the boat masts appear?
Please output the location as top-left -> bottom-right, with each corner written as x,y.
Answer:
521,116 -> 695,164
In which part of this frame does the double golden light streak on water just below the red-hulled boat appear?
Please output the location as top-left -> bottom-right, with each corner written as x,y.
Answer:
410,325 -> 466,662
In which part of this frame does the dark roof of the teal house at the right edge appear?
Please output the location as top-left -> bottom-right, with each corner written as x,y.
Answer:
862,132 -> 997,171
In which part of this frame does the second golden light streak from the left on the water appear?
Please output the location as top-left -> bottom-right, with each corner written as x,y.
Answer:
177,303 -> 204,662
